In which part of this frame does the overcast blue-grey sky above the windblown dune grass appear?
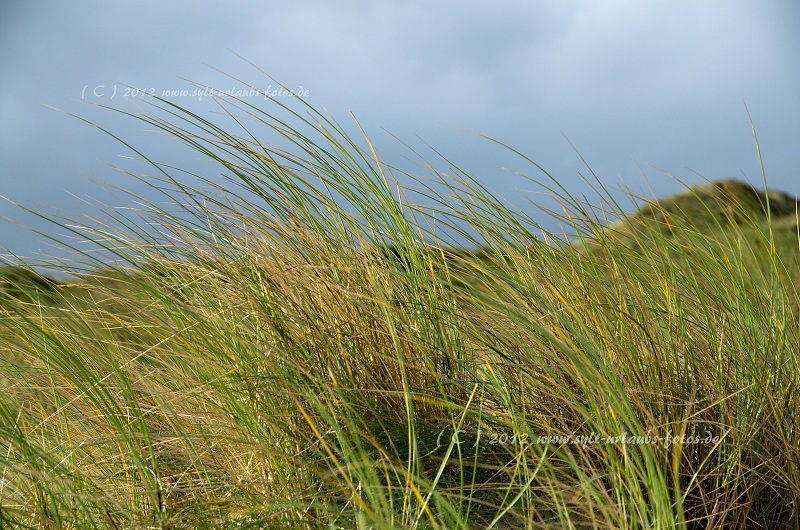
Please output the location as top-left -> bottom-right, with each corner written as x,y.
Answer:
0,0 -> 800,260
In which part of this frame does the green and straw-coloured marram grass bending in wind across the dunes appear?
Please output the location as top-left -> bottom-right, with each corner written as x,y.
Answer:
0,86 -> 800,529
